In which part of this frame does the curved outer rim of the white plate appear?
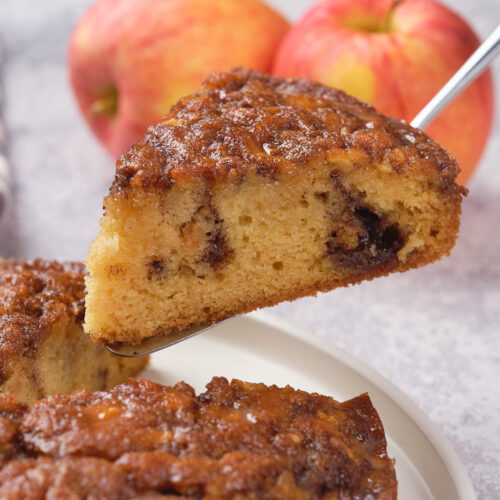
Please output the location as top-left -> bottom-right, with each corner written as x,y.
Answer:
247,310 -> 477,500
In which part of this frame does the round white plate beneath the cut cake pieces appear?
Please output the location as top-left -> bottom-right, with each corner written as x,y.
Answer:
142,312 -> 476,500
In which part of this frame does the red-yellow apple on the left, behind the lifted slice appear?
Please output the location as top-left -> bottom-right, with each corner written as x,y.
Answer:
69,0 -> 289,156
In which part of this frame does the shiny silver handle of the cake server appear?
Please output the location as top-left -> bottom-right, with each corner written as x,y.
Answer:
411,24 -> 500,130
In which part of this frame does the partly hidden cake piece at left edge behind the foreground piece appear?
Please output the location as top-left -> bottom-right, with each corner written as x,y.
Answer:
0,260 -> 147,404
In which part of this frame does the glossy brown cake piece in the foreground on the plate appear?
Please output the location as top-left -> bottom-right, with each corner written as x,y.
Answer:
0,377 -> 397,500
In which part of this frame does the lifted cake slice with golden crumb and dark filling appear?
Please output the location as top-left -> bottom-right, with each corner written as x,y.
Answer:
84,70 -> 465,344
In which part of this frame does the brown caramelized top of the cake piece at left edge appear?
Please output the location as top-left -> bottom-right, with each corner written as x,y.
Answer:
0,259 -> 85,383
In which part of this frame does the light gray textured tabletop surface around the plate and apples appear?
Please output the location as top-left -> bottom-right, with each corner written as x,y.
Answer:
0,0 -> 500,499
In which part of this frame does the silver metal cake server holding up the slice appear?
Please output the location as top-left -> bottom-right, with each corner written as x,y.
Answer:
106,25 -> 500,358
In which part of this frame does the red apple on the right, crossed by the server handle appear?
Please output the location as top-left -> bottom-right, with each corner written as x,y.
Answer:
273,0 -> 494,182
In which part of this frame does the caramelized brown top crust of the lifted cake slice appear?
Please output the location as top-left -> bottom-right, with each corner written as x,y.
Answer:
111,69 -> 463,194
